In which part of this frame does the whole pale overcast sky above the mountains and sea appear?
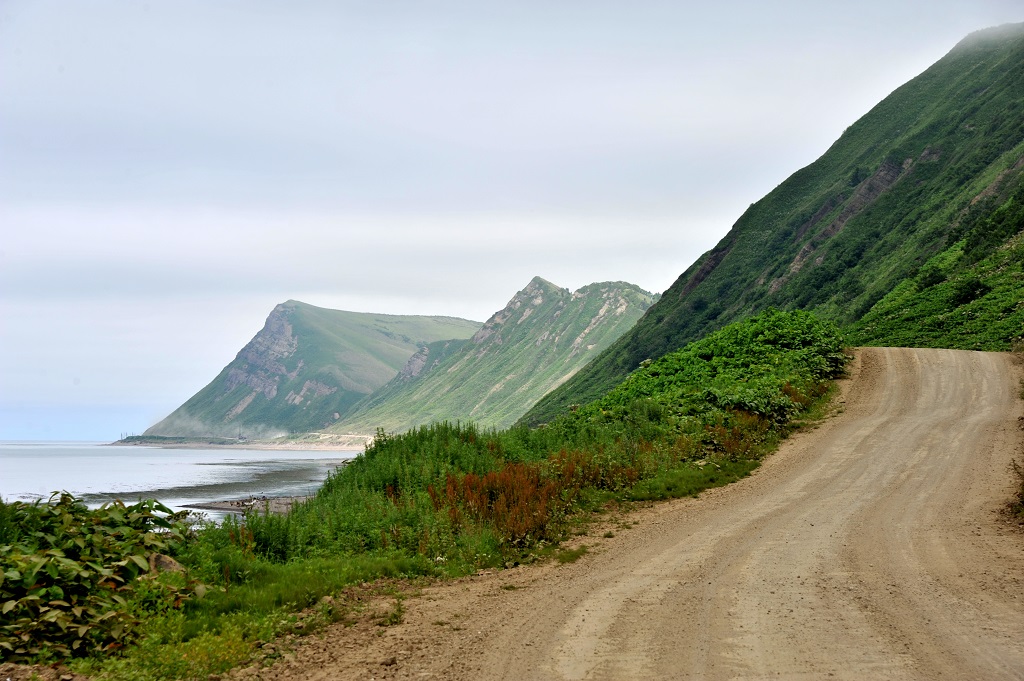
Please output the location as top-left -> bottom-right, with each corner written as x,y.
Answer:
0,0 -> 1024,440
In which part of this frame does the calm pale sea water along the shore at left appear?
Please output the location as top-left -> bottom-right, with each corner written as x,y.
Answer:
0,442 -> 358,518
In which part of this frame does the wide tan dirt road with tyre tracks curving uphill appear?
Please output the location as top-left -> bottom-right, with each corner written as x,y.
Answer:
241,348 -> 1024,680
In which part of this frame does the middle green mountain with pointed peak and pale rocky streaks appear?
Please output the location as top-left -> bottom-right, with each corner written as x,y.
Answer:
332,276 -> 653,433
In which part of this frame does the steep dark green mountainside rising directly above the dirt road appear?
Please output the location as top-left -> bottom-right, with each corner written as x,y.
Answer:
524,24 -> 1024,424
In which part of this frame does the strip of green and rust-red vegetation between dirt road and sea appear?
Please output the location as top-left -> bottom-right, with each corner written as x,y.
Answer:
0,309 -> 847,679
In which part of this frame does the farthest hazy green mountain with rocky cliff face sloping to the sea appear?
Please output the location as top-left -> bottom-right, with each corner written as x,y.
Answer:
144,300 -> 480,437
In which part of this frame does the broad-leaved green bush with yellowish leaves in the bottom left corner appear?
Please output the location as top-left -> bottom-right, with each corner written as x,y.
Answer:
0,494 -> 191,661
